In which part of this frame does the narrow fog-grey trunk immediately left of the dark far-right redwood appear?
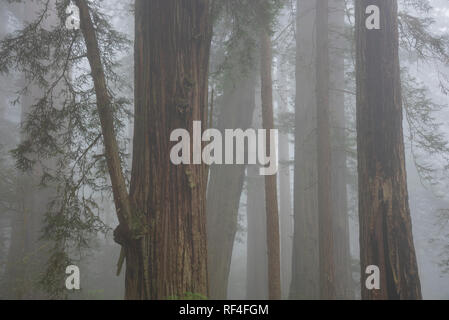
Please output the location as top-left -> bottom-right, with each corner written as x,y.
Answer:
329,0 -> 354,299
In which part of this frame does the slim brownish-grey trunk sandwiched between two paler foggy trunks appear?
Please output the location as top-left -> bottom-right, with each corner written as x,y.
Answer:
316,0 -> 335,299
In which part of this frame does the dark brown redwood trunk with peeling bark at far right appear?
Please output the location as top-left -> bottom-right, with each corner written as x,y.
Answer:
356,0 -> 422,299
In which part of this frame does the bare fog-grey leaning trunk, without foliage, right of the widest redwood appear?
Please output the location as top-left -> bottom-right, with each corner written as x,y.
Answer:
207,62 -> 256,299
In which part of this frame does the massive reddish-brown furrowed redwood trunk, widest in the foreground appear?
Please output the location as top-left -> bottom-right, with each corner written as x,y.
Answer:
126,0 -> 211,299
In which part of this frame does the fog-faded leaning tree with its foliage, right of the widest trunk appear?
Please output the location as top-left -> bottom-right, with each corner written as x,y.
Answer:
207,3 -> 258,299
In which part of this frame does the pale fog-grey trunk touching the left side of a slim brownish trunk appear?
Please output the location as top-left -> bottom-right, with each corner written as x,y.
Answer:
290,0 -> 319,299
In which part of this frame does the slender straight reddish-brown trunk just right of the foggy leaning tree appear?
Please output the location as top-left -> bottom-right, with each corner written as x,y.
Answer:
260,31 -> 281,300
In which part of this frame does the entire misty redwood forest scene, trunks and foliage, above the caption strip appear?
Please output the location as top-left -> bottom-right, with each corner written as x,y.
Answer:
0,0 -> 449,299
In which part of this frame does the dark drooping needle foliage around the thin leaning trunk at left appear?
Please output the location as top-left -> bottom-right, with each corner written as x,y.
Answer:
0,0 -> 132,297
